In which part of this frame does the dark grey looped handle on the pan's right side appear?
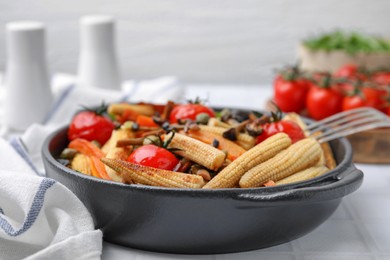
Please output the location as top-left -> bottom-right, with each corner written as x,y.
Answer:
235,164 -> 363,205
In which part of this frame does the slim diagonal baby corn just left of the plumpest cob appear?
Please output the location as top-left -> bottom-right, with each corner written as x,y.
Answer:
203,133 -> 291,189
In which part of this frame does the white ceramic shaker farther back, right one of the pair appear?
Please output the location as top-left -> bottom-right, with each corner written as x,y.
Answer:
78,15 -> 121,90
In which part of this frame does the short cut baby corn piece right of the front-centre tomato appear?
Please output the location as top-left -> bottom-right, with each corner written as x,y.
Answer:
164,133 -> 226,171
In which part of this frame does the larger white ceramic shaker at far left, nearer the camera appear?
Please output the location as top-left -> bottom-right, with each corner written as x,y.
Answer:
4,21 -> 53,131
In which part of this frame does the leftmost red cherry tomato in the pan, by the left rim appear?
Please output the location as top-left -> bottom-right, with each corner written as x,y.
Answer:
68,111 -> 115,144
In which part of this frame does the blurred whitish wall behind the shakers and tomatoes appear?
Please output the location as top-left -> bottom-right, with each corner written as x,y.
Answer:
0,0 -> 390,84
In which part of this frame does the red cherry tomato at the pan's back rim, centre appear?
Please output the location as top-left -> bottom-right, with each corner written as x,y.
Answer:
169,103 -> 215,123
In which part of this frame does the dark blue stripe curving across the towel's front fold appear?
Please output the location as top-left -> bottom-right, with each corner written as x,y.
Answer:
0,178 -> 55,237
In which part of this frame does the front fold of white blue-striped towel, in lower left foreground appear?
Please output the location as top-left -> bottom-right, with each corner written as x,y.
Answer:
0,138 -> 102,259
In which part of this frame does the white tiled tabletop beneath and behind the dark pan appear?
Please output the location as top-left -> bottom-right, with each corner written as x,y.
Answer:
102,85 -> 390,260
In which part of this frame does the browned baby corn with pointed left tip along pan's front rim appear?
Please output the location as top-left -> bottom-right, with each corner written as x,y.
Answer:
101,158 -> 205,189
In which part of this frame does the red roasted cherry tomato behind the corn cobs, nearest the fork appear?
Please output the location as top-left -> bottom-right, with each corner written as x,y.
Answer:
256,120 -> 305,143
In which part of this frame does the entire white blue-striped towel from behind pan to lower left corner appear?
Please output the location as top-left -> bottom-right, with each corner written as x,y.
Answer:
0,75 -> 184,259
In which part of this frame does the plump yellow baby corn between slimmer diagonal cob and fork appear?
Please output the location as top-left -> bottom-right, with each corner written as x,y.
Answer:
239,138 -> 322,188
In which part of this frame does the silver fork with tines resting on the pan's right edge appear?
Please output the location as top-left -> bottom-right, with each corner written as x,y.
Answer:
305,107 -> 390,143
